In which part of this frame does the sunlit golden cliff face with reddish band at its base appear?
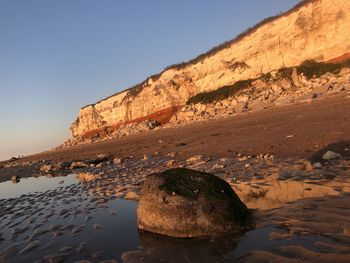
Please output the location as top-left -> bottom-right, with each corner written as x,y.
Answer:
71,0 -> 350,138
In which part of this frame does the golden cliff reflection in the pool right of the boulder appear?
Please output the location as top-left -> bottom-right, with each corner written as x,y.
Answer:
231,177 -> 350,210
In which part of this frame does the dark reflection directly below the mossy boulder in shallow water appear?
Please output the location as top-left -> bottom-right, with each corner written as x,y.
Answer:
122,232 -> 239,263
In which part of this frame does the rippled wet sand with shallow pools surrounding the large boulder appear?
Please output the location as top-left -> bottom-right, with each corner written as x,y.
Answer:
0,158 -> 350,262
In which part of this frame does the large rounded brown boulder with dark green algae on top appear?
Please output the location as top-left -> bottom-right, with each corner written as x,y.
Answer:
137,168 -> 253,238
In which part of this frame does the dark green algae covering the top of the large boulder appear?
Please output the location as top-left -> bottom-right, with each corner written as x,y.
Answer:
159,168 -> 253,228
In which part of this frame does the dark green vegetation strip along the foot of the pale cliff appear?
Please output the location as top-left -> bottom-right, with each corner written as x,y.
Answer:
186,60 -> 350,105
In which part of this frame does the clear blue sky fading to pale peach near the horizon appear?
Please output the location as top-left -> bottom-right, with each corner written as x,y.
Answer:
0,0 -> 299,160
